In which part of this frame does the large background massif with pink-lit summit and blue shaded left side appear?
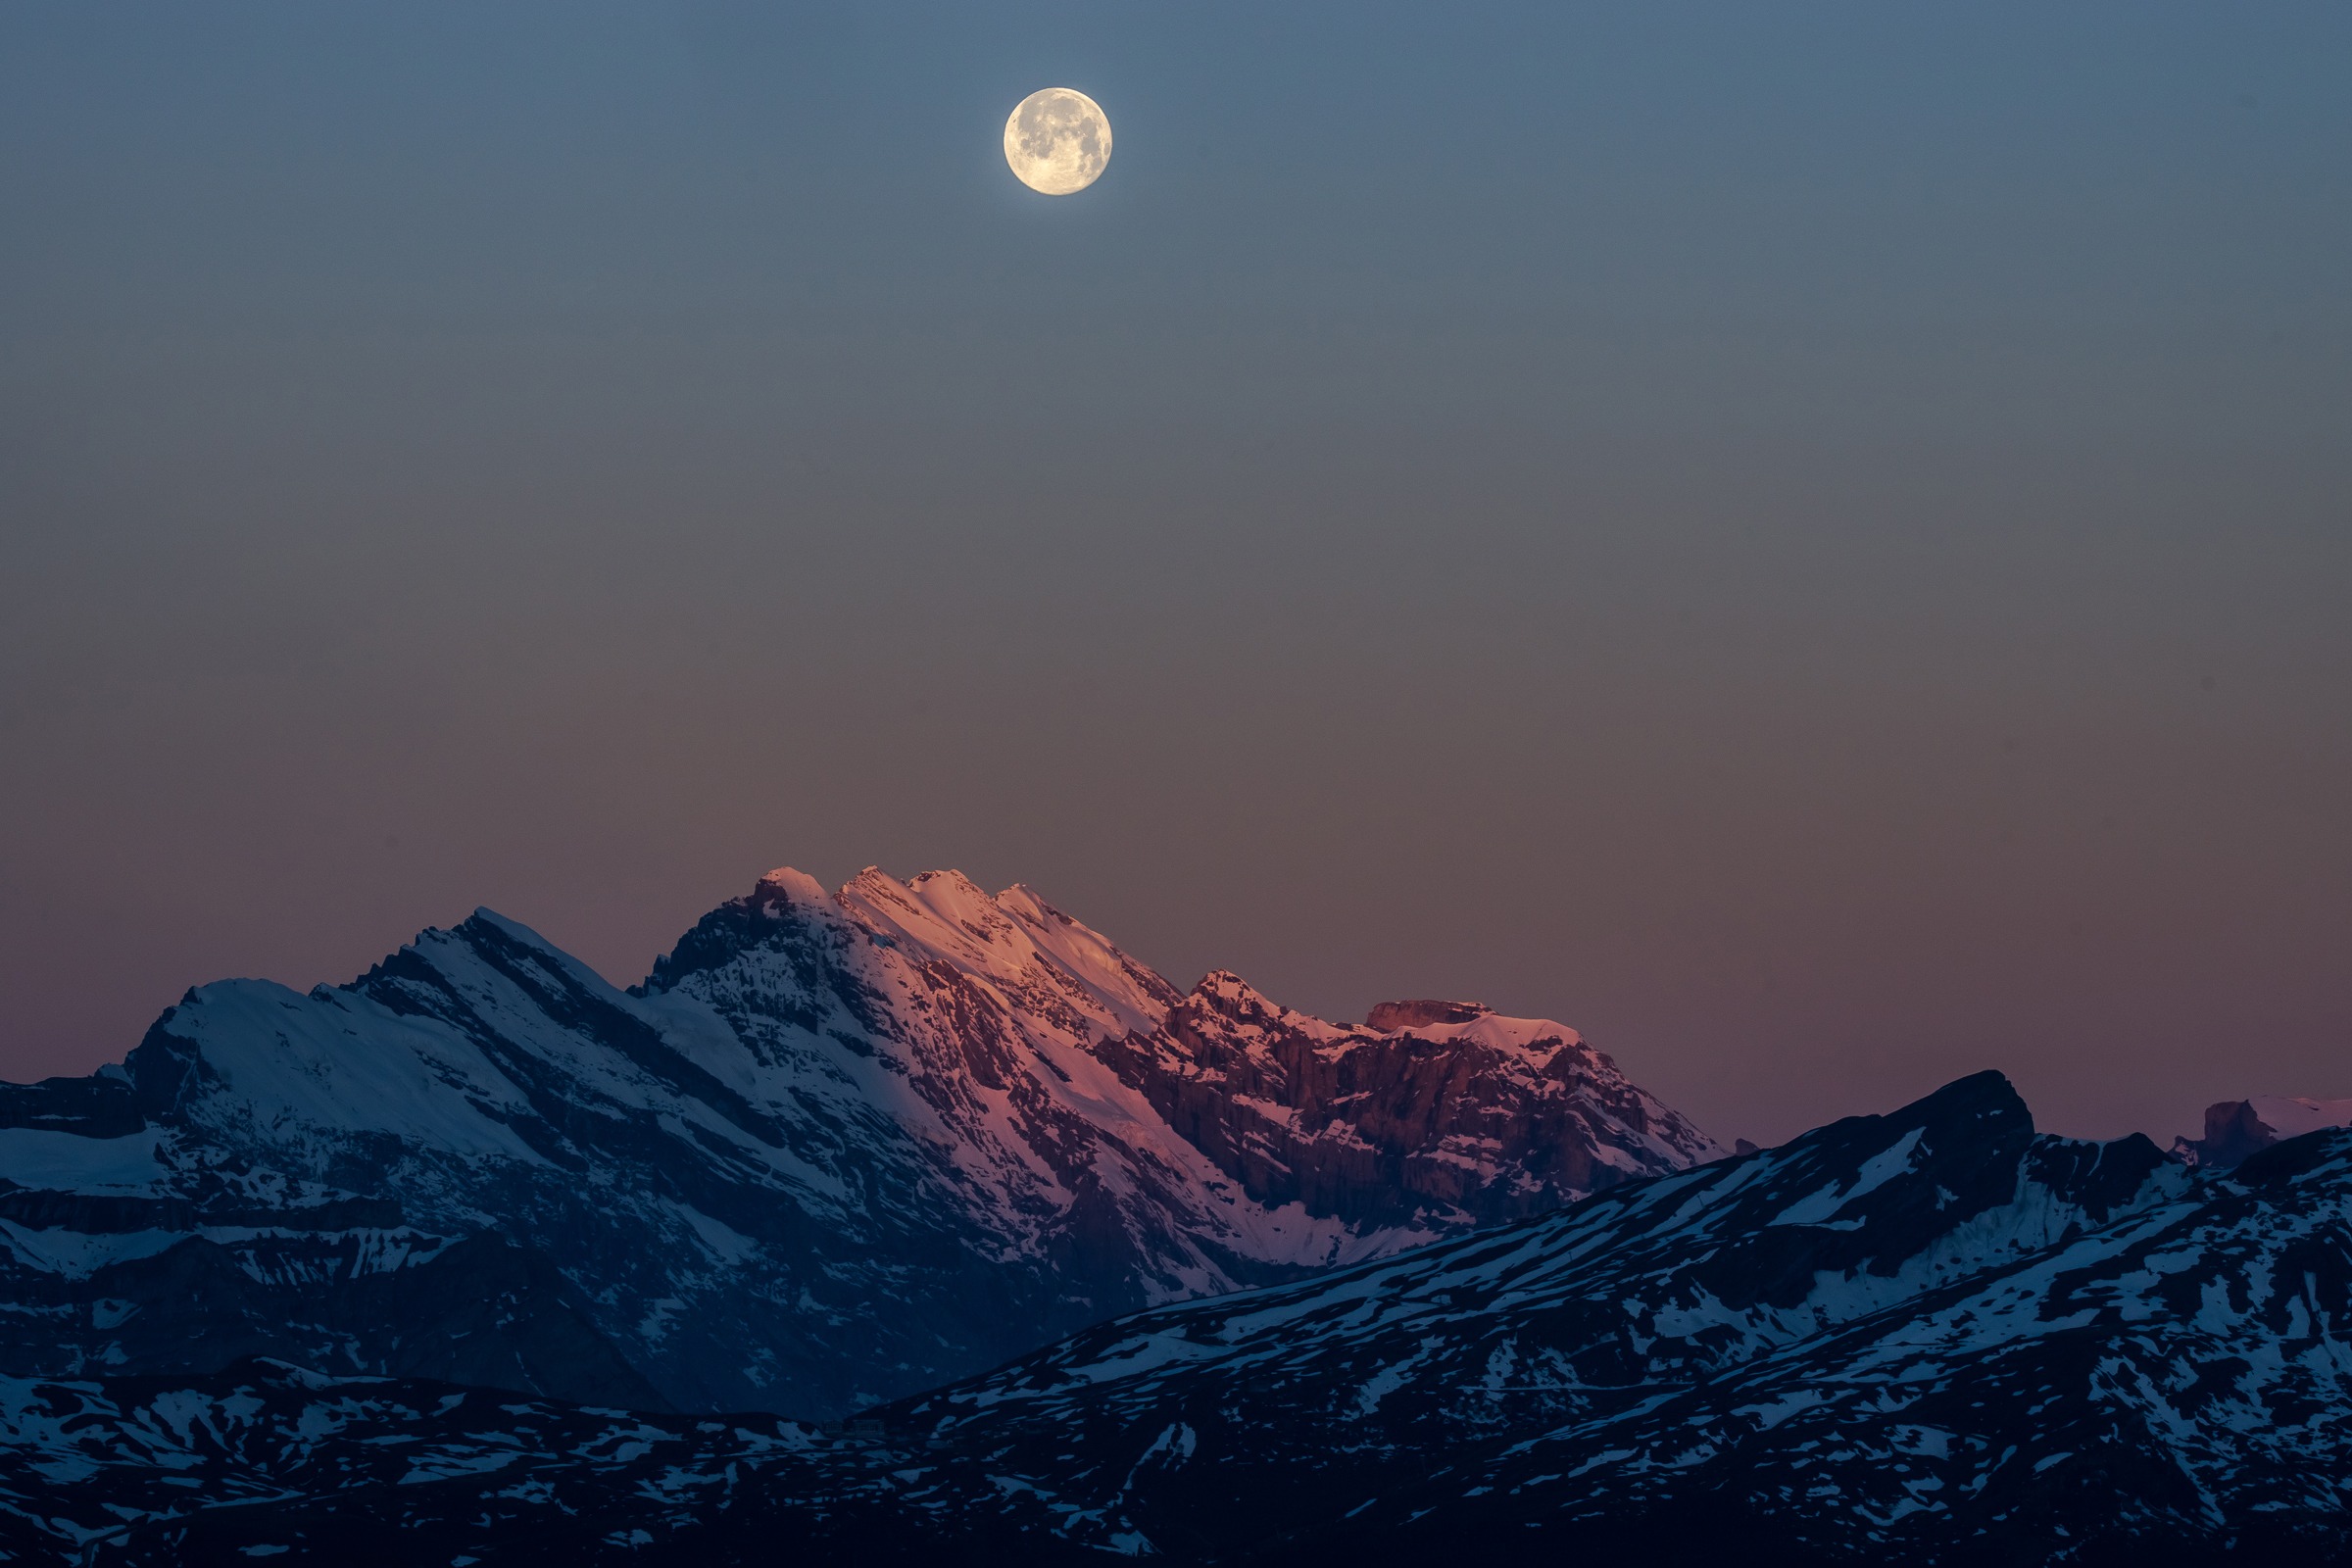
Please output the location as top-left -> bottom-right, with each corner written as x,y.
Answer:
0,870 -> 1719,1417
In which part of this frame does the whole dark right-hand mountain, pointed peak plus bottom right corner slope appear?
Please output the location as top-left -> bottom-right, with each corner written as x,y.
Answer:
672,1074 -> 2352,1566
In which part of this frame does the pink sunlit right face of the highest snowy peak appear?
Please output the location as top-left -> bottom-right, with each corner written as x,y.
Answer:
686,867 -> 1724,1241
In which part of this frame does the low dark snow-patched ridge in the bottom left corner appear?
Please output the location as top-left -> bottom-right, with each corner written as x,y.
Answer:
0,1363 -> 823,1568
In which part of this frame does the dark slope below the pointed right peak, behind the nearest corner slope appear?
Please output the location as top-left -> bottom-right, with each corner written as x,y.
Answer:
808,1074 -> 2192,1544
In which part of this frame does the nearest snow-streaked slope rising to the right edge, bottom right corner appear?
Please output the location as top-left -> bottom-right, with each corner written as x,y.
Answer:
1331,1131 -> 2352,1563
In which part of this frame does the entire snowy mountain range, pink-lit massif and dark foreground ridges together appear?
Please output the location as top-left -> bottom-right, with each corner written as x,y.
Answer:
0,872 -> 2352,1568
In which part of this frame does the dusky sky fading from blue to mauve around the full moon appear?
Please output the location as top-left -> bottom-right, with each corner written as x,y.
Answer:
0,0 -> 2352,1143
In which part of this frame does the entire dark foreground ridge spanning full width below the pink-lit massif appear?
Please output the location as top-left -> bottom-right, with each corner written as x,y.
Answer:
18,1074 -> 2352,1568
